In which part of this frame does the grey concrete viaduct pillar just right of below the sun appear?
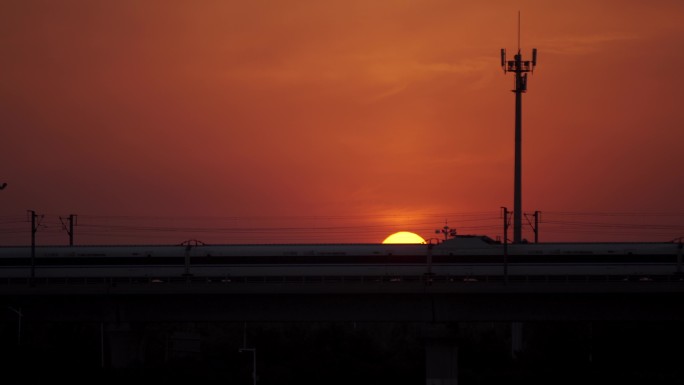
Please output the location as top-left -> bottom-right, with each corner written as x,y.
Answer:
425,325 -> 458,385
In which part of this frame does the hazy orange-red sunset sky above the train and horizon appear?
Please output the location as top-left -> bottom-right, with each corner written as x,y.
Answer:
0,0 -> 684,245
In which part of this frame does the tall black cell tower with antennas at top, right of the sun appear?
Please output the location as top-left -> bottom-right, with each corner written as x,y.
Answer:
501,12 -> 537,243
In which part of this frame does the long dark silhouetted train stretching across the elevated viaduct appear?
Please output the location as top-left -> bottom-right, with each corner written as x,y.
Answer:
0,235 -> 682,279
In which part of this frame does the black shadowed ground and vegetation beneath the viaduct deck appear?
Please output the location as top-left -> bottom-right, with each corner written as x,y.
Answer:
0,322 -> 684,385
